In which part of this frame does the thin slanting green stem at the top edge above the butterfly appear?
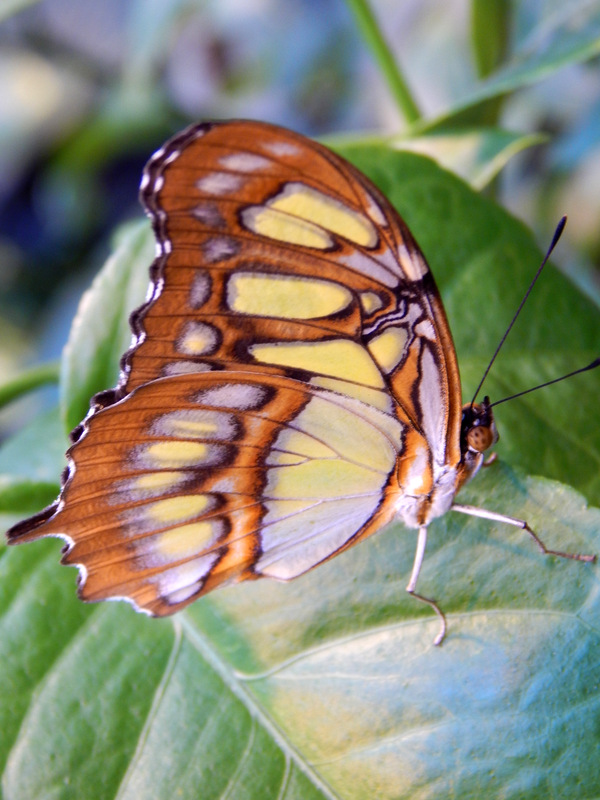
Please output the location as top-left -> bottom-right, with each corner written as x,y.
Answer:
346,0 -> 421,124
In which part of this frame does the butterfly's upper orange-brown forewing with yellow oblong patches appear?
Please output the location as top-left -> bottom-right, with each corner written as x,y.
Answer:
122,122 -> 461,464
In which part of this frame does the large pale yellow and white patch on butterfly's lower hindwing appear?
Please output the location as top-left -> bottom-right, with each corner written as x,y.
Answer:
256,392 -> 402,580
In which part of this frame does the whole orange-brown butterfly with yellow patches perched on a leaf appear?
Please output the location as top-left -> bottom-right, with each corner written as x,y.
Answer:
8,121 -> 590,643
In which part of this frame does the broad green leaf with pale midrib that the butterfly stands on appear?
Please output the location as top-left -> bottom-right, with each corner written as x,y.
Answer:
0,464 -> 600,800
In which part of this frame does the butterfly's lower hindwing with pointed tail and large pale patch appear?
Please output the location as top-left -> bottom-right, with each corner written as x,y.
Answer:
11,371 -> 402,615
